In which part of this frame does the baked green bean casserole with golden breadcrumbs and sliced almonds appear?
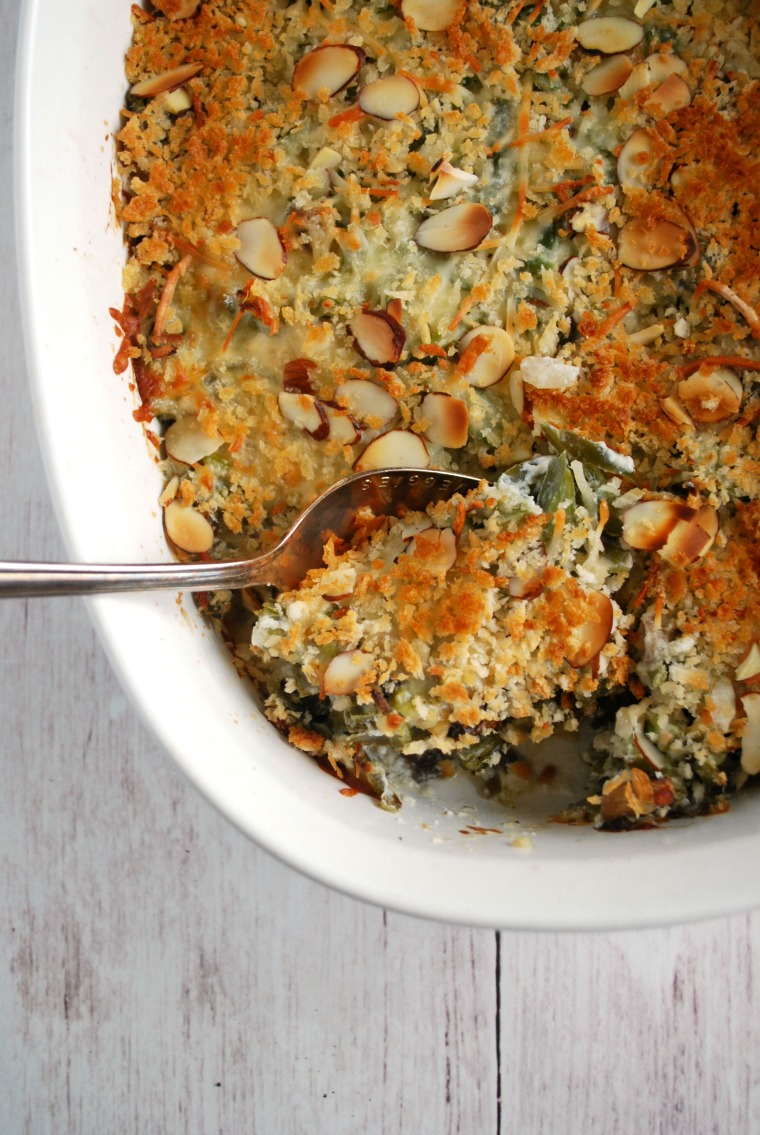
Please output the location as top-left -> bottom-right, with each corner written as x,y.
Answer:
112,0 -> 760,829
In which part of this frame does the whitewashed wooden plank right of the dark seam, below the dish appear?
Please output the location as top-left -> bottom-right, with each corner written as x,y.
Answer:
500,915 -> 760,1135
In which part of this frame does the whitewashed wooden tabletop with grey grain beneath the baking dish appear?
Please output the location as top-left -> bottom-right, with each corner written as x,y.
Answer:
0,0 -> 760,1135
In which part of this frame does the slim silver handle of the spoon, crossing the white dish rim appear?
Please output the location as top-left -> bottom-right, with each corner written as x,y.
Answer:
0,555 -> 270,599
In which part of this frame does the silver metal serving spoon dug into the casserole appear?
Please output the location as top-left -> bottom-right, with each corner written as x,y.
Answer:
0,469 -> 480,598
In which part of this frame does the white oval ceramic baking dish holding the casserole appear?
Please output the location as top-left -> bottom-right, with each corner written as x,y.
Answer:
17,0 -> 760,928
